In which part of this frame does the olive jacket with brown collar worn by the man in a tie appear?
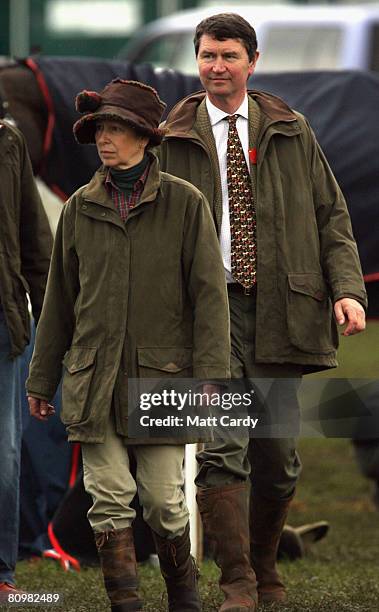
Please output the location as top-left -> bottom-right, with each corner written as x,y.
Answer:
159,91 -> 367,372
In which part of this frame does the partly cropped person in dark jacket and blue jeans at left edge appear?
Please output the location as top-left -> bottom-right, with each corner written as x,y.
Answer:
0,121 -> 52,599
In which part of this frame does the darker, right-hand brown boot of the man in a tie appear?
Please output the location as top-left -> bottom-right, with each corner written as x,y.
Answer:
250,494 -> 291,603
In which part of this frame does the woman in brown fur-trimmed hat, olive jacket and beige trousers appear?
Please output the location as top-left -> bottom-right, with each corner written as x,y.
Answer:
27,79 -> 229,612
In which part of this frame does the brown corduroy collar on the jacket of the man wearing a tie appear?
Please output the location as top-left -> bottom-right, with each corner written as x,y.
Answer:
164,89 -> 297,138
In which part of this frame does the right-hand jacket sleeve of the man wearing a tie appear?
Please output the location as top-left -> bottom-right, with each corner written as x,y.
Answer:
305,115 -> 367,308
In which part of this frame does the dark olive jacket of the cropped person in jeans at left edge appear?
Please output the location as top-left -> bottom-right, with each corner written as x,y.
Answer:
0,121 -> 53,358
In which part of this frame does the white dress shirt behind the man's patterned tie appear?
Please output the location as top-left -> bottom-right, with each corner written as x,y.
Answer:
205,94 -> 250,283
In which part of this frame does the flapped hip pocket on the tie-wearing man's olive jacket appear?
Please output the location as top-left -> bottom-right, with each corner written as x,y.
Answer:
287,272 -> 338,354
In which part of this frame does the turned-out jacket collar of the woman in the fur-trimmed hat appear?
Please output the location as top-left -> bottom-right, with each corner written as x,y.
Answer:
83,151 -> 161,214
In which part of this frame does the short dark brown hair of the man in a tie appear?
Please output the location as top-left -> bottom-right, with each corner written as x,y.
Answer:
193,13 -> 258,61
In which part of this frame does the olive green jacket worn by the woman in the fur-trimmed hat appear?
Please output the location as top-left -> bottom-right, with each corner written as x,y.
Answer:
27,158 -> 230,443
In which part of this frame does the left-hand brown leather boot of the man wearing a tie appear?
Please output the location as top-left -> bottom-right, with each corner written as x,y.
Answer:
197,483 -> 258,612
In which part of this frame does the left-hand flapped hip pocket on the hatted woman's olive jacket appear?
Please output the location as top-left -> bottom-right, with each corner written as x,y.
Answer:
61,346 -> 97,425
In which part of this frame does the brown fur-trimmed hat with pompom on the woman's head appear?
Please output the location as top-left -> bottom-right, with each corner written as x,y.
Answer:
73,78 -> 166,145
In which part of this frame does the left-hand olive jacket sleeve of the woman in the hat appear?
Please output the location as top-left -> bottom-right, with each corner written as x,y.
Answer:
26,196 -> 79,400
